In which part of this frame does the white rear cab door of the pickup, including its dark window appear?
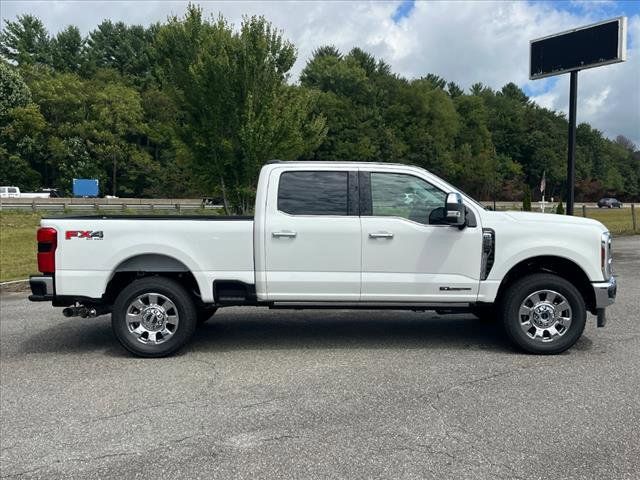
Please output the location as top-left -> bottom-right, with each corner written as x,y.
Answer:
264,167 -> 362,301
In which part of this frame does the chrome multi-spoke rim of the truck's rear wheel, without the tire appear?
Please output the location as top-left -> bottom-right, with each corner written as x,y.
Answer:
127,293 -> 180,345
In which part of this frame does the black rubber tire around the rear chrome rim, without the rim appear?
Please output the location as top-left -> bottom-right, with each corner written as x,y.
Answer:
111,277 -> 197,357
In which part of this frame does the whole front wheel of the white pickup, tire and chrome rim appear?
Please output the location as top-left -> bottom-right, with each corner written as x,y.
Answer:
500,273 -> 587,354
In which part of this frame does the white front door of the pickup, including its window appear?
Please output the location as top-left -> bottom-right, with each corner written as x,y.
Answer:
360,172 -> 482,303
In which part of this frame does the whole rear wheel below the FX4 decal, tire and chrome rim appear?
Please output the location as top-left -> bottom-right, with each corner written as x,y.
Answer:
111,277 -> 197,357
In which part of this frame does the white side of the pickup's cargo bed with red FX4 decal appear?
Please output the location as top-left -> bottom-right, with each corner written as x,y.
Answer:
41,215 -> 255,301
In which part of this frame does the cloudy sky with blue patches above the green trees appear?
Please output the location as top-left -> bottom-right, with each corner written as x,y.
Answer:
0,0 -> 640,147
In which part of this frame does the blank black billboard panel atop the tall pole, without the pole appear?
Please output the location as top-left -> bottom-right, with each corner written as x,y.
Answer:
529,17 -> 627,80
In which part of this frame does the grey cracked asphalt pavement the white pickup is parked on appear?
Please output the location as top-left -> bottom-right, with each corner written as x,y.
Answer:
0,237 -> 640,479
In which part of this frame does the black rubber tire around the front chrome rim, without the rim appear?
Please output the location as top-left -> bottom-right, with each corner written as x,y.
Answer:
500,273 -> 587,354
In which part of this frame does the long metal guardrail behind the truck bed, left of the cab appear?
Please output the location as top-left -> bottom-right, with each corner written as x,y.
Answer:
0,198 -> 224,213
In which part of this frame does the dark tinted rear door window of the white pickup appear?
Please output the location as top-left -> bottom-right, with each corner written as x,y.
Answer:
278,171 -> 349,215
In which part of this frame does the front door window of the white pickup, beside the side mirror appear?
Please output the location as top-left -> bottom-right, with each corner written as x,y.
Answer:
371,172 -> 446,224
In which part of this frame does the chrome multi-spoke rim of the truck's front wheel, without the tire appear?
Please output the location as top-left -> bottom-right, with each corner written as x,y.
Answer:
519,290 -> 572,343
